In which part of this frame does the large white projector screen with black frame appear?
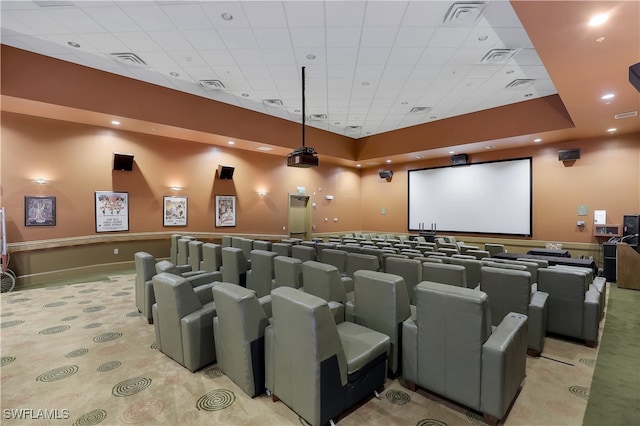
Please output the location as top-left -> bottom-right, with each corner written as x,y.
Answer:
409,157 -> 533,236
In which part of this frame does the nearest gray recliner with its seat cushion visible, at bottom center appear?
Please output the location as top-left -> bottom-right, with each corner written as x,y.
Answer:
265,287 -> 389,426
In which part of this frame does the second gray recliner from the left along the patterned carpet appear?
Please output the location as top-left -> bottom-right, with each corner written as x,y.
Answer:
153,273 -> 216,372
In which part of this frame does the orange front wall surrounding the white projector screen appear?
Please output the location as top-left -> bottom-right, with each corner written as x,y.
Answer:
361,134 -> 640,243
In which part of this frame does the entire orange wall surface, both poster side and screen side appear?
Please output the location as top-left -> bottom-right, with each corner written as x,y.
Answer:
0,113 -> 640,243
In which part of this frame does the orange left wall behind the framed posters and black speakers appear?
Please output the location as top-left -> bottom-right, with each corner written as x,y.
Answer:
1,112 -> 361,243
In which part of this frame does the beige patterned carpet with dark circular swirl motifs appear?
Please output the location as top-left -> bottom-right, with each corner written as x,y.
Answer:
0,274 -> 604,426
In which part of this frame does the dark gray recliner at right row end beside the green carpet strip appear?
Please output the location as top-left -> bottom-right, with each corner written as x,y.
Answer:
538,268 -> 601,347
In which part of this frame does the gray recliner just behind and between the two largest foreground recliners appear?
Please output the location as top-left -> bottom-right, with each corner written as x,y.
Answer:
347,270 -> 412,377
